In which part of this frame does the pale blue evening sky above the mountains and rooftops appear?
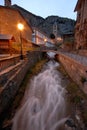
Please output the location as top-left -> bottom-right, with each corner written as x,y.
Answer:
0,0 -> 77,20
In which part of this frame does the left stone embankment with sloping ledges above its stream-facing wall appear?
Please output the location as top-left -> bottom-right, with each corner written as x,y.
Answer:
0,52 -> 42,121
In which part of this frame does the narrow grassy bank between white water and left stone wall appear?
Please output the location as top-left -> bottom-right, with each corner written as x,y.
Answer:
2,59 -> 47,130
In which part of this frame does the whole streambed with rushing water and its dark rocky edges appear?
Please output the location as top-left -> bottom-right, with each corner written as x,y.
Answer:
1,53 -> 87,130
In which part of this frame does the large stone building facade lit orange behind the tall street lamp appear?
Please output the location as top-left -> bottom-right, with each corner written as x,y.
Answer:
0,6 -> 33,52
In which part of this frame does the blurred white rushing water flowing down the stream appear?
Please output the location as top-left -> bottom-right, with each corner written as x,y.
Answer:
12,61 -> 66,130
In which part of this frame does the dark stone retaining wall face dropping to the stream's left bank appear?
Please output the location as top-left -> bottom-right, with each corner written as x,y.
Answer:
0,52 -> 42,119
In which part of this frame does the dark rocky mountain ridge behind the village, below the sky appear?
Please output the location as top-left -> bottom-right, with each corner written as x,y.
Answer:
12,5 -> 75,36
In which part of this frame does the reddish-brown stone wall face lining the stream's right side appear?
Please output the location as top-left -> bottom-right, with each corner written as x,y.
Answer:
57,54 -> 87,94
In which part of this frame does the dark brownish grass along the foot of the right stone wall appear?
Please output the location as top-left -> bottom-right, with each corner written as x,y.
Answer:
58,65 -> 87,125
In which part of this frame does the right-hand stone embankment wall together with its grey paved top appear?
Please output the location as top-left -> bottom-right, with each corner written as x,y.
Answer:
56,53 -> 87,94
